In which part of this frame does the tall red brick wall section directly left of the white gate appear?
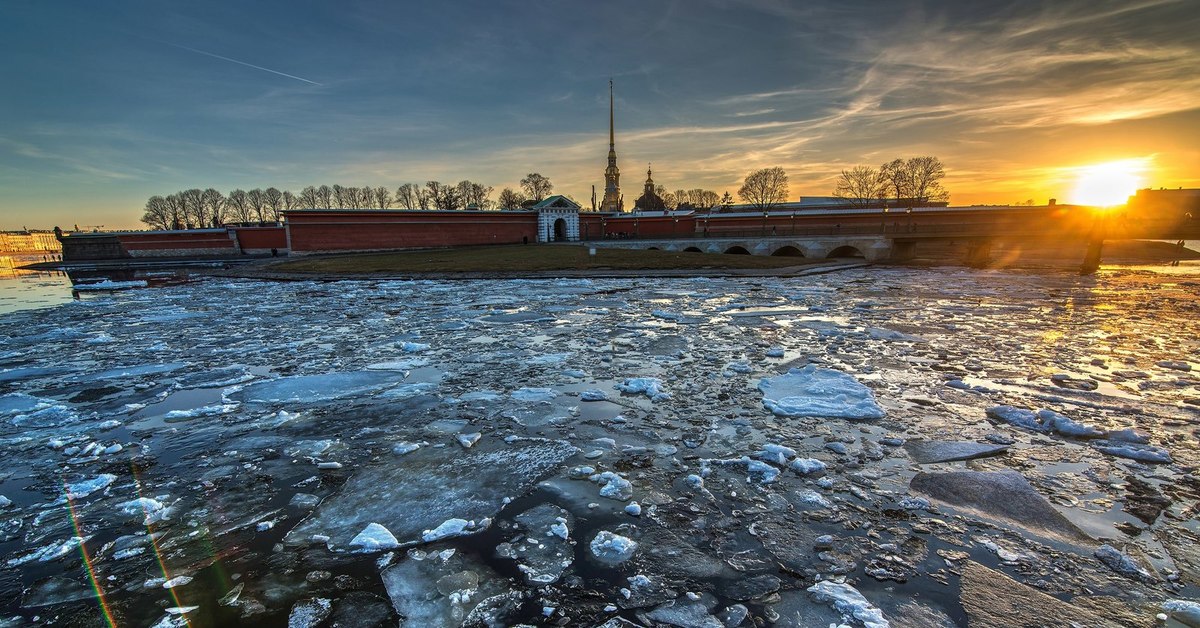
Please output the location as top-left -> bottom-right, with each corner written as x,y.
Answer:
287,210 -> 538,253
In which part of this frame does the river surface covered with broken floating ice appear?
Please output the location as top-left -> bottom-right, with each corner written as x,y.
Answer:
0,269 -> 1200,627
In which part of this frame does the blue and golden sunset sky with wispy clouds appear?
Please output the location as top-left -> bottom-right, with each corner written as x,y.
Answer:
0,0 -> 1200,229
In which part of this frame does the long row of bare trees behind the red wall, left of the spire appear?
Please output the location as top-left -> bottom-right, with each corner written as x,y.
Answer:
142,173 -> 554,229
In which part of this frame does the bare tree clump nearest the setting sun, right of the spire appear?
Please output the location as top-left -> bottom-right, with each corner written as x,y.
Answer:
833,156 -> 950,208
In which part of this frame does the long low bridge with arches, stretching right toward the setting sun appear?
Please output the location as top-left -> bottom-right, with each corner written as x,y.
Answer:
580,205 -> 1200,273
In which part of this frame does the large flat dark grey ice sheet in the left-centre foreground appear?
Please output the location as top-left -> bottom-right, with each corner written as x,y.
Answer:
284,439 -> 576,550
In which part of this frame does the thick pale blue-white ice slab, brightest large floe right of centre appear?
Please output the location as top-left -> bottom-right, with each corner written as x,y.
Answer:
758,364 -> 884,419
